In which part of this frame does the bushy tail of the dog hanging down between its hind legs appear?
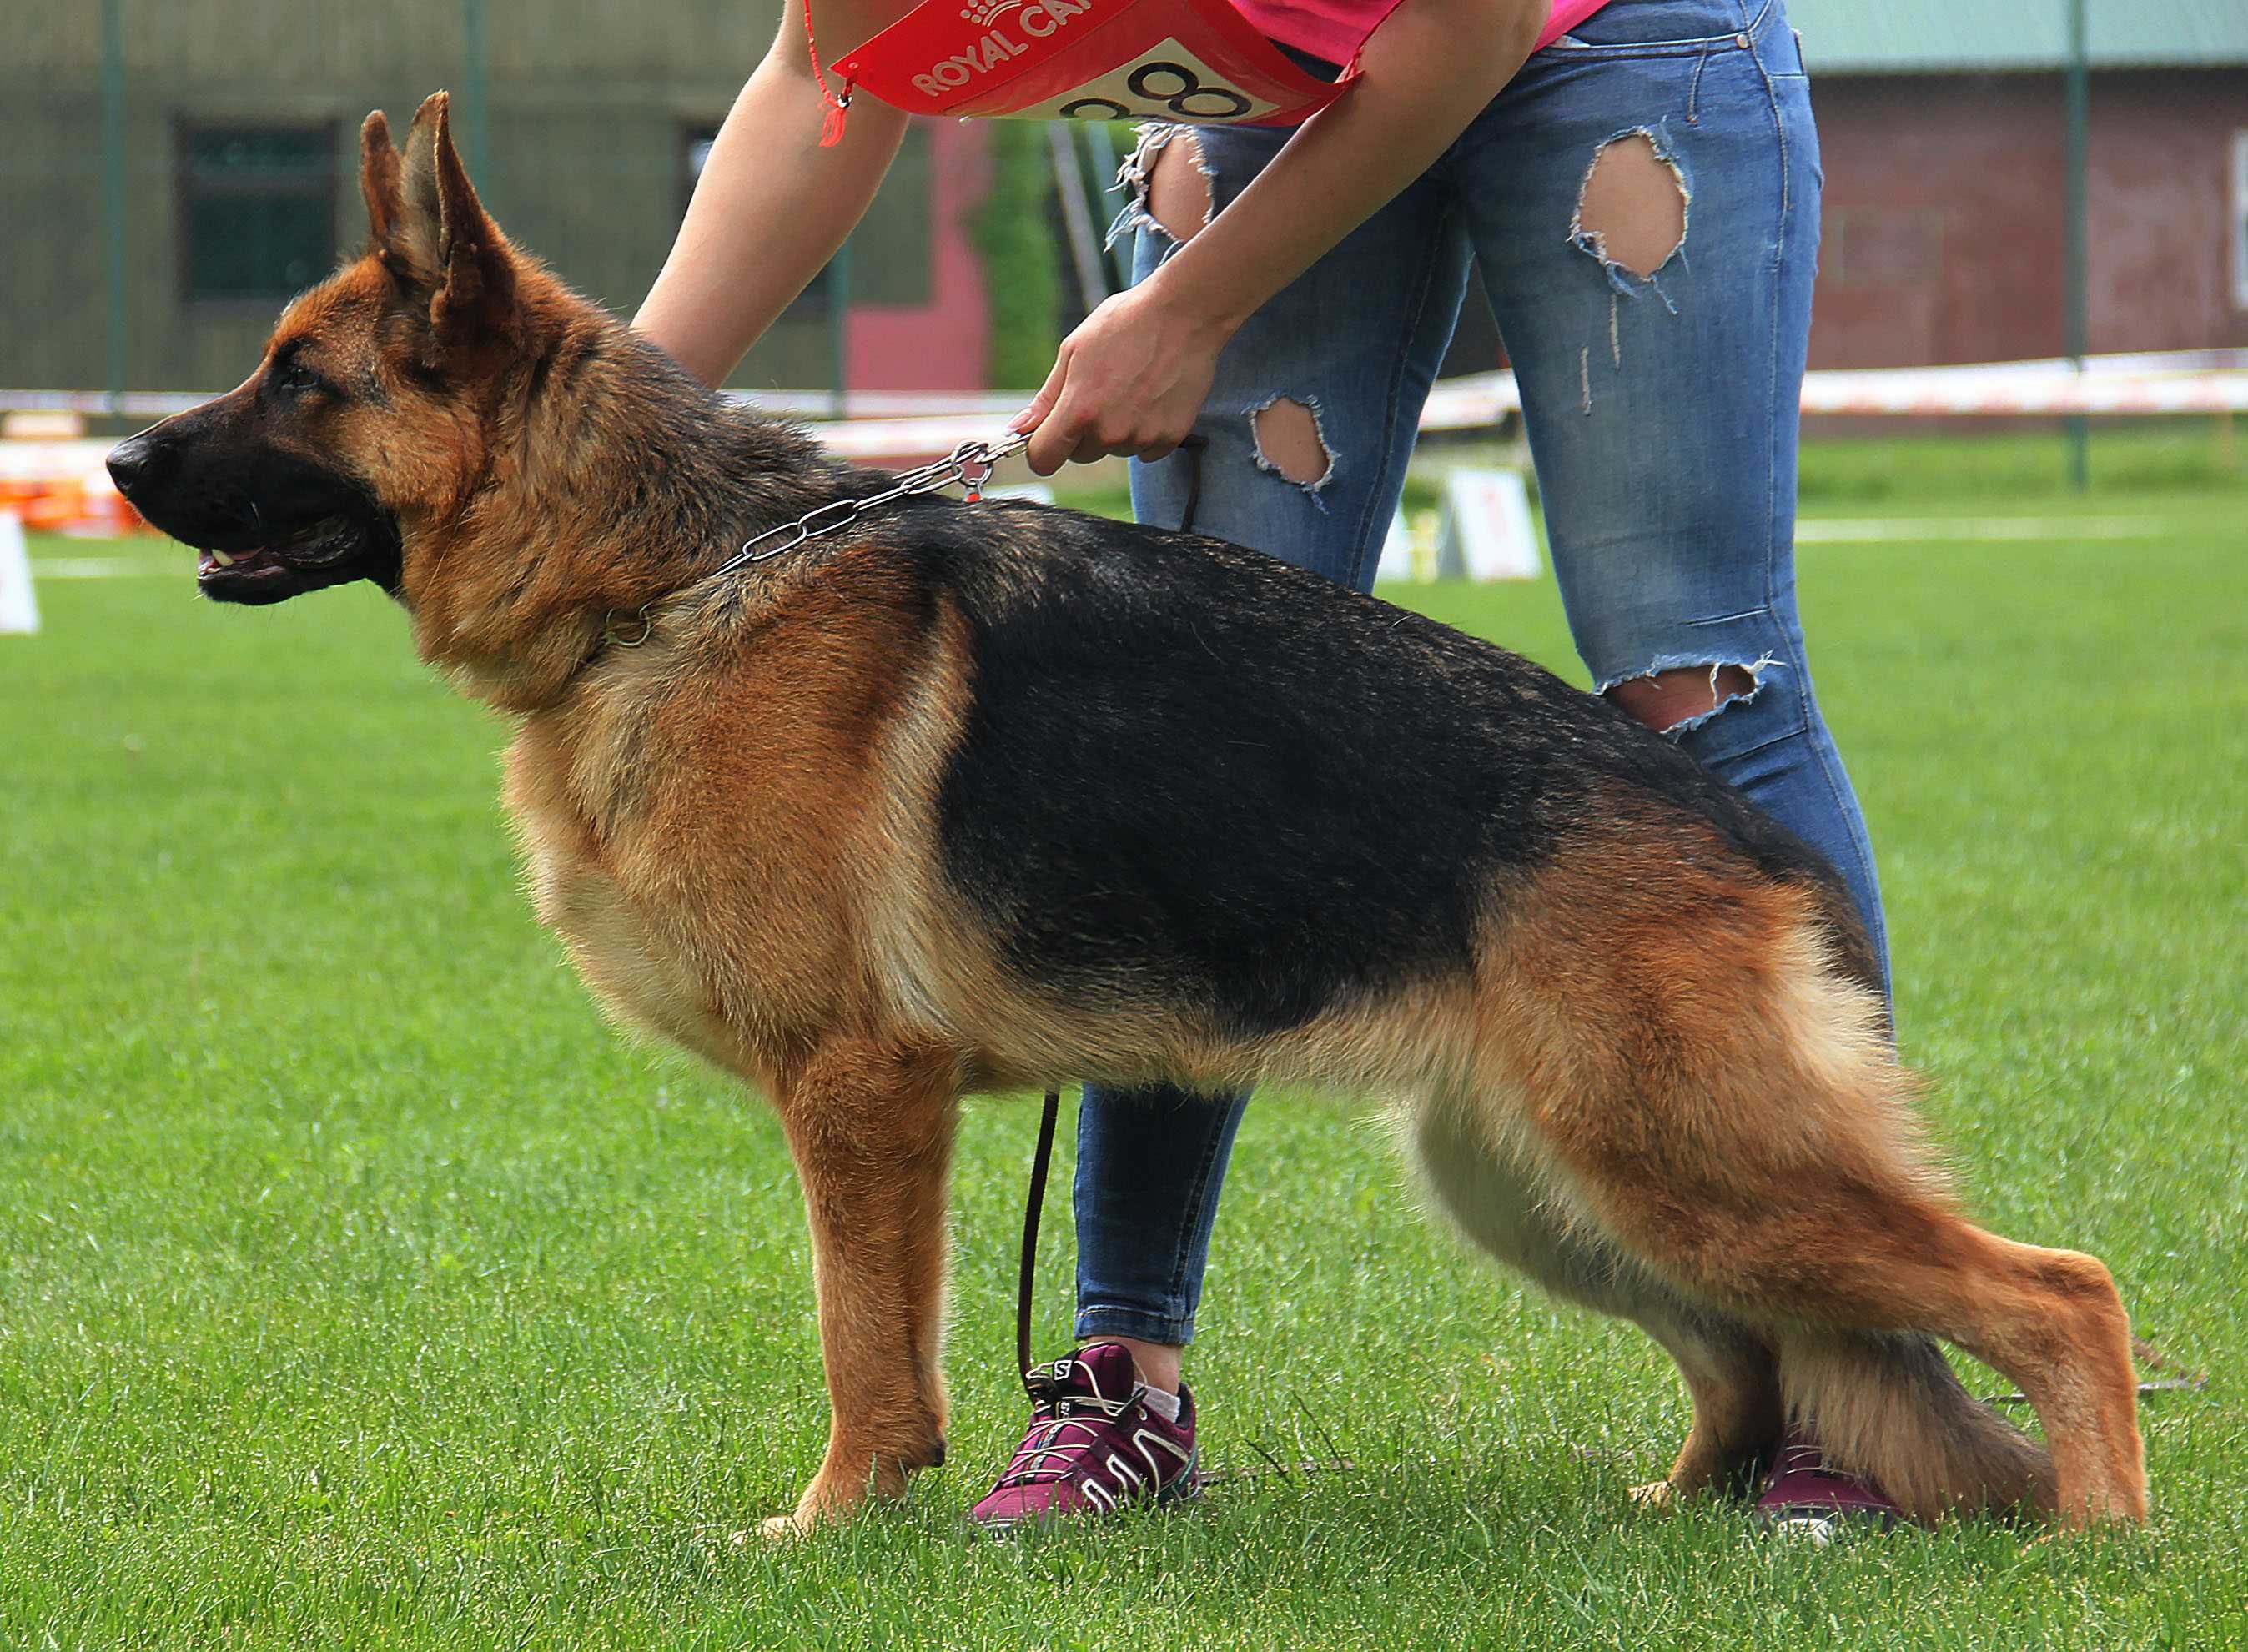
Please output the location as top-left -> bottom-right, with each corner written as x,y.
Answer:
1780,1333 -> 2054,1519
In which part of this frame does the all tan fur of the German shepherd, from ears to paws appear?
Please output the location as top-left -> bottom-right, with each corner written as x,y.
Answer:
166,99 -> 2145,1526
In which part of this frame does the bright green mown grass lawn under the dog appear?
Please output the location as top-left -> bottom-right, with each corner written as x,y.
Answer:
0,492 -> 2248,1652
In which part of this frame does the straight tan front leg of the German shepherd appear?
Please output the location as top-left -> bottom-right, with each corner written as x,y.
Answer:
767,1043 -> 960,1535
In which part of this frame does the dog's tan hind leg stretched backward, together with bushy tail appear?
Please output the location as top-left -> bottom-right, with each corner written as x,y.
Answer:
1517,883 -> 2147,1524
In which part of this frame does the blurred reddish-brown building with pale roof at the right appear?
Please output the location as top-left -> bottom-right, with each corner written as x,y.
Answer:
1789,0 -> 2248,366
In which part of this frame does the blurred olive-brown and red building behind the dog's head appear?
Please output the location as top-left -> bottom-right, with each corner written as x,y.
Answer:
0,0 -> 989,389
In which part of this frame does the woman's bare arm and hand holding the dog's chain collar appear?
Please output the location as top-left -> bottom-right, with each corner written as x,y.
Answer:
1013,0 -> 1551,476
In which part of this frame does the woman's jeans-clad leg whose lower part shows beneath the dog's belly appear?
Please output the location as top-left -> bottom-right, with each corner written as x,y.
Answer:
1074,128 -> 1468,1387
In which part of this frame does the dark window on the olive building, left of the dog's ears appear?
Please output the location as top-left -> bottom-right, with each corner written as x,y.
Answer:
180,126 -> 335,304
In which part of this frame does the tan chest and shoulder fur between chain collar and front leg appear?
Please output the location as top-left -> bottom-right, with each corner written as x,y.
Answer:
505,575 -> 953,1092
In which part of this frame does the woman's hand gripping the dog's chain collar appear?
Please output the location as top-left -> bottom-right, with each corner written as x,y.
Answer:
1009,272 -> 1239,476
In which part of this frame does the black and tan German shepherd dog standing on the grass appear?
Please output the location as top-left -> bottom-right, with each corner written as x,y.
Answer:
113,94 -> 2147,1530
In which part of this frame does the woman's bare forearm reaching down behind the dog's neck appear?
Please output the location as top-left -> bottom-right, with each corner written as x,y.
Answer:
631,4 -> 906,384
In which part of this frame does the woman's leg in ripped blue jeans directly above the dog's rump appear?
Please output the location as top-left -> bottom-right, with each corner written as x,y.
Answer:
1455,0 -> 1888,980
